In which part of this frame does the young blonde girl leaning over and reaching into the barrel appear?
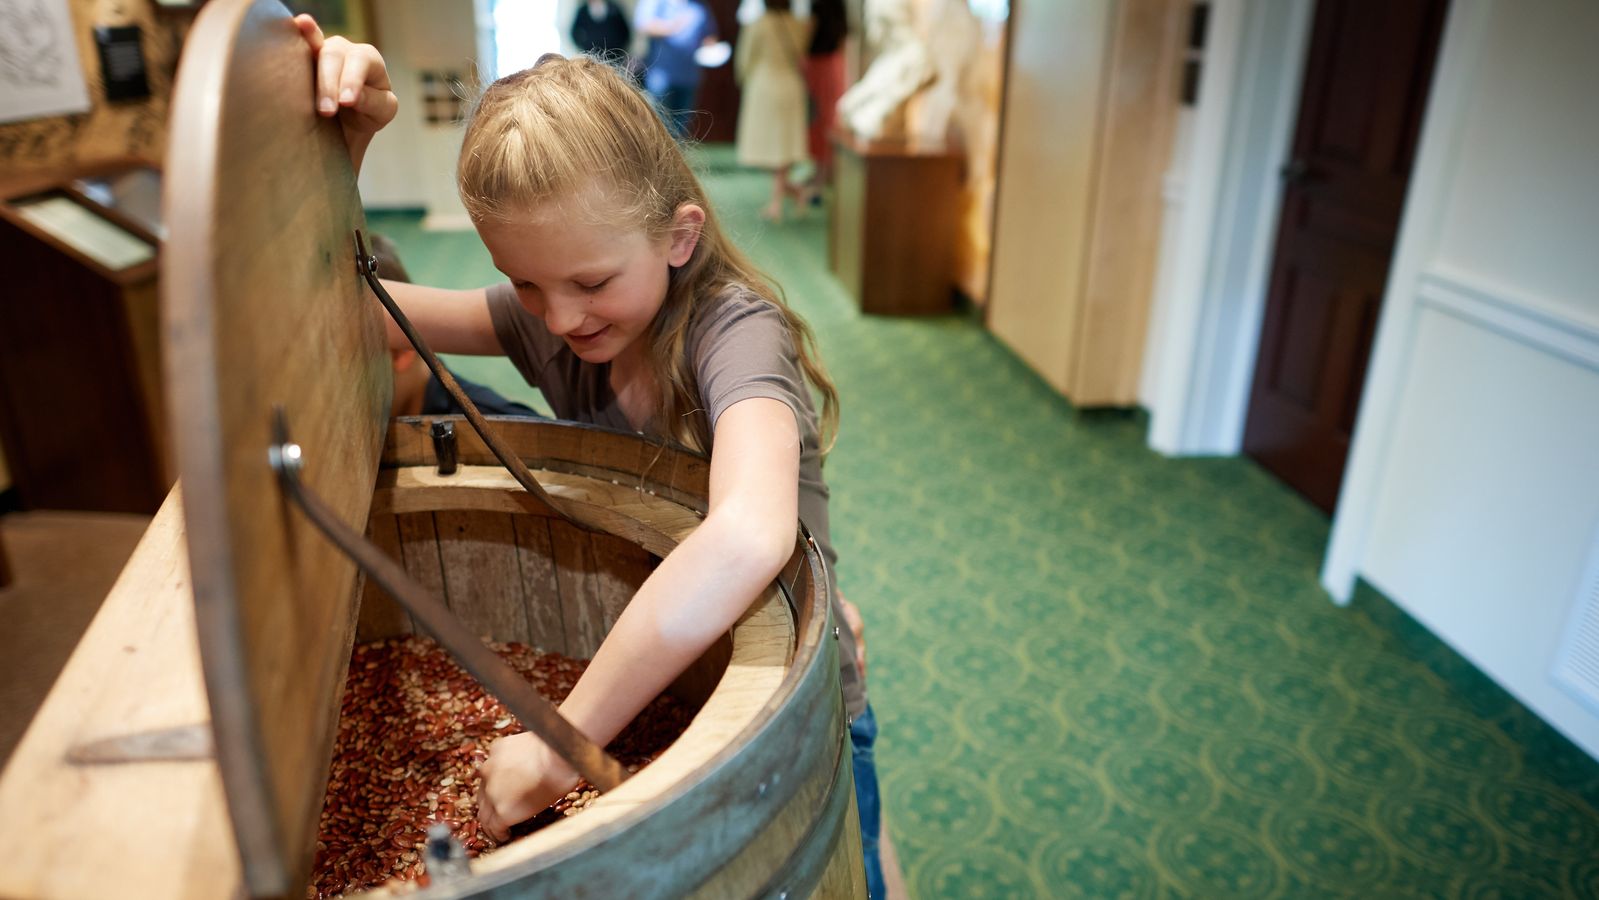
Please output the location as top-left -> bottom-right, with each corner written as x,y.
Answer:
296,16 -> 883,897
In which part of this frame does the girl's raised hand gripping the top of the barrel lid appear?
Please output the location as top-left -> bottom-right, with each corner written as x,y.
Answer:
294,13 -> 400,171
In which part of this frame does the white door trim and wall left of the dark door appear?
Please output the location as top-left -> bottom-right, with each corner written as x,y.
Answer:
1140,0 -> 1313,456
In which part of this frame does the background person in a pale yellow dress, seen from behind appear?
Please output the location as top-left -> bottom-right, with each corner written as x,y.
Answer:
734,0 -> 811,222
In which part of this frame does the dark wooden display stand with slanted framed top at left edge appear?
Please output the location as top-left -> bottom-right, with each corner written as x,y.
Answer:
0,164 -> 173,513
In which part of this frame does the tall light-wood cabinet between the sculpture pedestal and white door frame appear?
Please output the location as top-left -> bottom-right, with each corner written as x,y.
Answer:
987,0 -> 1188,406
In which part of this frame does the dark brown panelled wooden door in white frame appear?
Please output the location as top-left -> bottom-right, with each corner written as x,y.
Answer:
1244,0 -> 1447,512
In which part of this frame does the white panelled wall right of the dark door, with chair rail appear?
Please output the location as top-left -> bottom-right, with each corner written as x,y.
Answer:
1322,0 -> 1599,756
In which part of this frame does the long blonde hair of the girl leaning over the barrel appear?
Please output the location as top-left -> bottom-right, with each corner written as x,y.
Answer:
456,53 -> 838,454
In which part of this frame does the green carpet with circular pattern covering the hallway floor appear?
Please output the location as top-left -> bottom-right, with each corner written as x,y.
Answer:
373,147 -> 1599,898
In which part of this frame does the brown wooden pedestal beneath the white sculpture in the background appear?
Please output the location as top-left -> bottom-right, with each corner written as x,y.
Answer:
828,134 -> 961,315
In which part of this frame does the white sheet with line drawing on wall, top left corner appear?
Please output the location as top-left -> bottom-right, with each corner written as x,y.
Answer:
0,0 -> 90,121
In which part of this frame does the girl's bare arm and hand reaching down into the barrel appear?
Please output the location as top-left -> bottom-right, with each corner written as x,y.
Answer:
478,396 -> 800,839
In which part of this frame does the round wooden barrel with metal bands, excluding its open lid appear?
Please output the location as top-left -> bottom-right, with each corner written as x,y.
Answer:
360,419 -> 863,897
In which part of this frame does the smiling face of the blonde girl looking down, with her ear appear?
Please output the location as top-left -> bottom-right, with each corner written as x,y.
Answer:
478,205 -> 705,363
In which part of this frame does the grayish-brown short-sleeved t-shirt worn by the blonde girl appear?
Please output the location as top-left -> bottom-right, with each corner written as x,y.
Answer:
488,283 -> 867,716
